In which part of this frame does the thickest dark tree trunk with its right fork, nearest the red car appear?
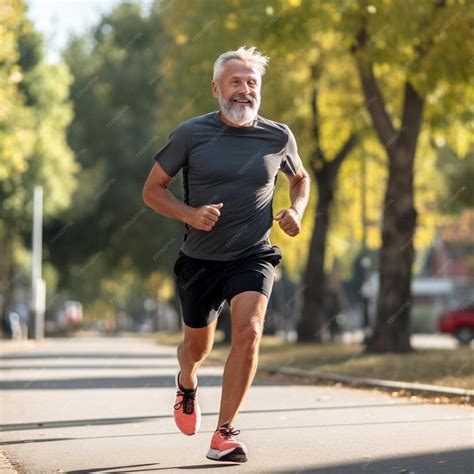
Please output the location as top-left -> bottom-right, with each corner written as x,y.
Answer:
366,83 -> 423,352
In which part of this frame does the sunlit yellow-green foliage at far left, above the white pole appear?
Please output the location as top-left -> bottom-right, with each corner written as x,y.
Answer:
0,2 -> 76,231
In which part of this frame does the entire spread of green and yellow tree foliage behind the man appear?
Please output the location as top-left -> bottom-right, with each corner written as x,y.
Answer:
9,0 -> 468,312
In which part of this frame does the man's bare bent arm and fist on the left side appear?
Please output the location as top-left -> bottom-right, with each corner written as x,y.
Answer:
143,163 -> 223,231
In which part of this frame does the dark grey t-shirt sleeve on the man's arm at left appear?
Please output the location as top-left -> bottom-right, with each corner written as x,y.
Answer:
153,123 -> 191,177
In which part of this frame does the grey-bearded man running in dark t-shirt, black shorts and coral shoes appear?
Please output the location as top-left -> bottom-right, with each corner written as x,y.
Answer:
143,46 -> 310,462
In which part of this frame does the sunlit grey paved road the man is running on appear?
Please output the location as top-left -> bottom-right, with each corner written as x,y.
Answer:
0,338 -> 474,474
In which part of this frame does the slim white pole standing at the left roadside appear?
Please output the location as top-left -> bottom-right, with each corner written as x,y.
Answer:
31,186 -> 46,339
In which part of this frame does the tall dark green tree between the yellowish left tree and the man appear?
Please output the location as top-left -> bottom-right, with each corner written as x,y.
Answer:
46,3 -> 167,299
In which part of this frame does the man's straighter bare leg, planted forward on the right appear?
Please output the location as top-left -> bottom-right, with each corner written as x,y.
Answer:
218,291 -> 268,426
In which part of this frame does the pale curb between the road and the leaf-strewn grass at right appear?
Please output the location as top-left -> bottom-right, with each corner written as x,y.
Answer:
259,364 -> 474,398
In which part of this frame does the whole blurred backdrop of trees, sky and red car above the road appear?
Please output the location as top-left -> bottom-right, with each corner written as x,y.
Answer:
0,0 -> 474,352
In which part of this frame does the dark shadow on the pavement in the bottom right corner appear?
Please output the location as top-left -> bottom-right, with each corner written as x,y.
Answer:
278,449 -> 474,474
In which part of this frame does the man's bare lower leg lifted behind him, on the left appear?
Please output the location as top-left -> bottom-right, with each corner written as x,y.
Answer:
177,319 -> 217,389
